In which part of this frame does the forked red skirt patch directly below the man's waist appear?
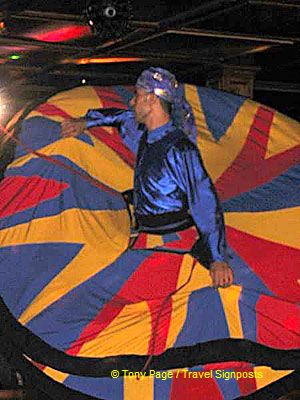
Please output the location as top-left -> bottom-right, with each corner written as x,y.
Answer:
68,253 -> 182,355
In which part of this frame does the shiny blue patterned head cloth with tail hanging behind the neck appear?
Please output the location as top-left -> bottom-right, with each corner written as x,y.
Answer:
136,67 -> 197,138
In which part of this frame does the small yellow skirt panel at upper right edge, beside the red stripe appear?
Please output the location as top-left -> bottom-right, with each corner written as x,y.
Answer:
265,112 -> 300,158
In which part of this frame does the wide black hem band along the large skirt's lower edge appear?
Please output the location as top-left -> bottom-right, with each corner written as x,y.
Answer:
0,301 -> 300,377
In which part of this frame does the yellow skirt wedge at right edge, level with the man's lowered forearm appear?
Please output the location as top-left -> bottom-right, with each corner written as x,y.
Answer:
225,207 -> 300,249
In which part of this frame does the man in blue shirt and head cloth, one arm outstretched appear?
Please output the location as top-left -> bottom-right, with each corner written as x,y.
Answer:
62,68 -> 233,288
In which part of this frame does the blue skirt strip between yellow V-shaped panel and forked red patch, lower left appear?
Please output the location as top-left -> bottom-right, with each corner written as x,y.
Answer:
28,251 -> 149,350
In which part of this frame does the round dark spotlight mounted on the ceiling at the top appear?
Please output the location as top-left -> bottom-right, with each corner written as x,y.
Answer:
85,0 -> 132,40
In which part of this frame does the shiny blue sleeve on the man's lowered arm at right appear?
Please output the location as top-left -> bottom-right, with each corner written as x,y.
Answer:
168,140 -> 226,265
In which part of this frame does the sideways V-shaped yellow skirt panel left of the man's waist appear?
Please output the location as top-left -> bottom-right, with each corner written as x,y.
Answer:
0,209 -> 129,324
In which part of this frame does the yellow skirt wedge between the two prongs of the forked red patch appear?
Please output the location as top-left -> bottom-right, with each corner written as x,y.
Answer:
78,301 -> 152,357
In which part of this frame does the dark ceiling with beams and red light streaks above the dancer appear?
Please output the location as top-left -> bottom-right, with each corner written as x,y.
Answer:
0,0 -> 300,119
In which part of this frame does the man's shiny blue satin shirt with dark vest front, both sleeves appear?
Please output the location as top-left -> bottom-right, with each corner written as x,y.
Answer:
85,109 -> 226,262
